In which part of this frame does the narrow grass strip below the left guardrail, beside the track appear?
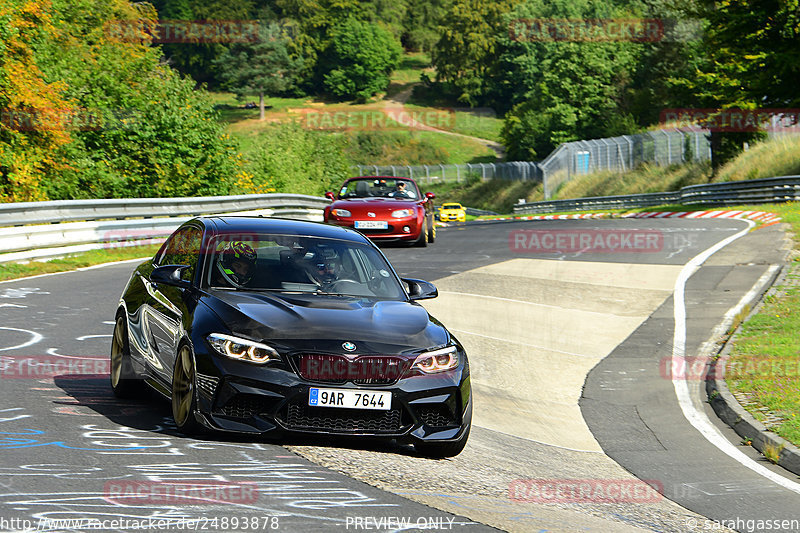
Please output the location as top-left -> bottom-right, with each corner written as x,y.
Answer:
0,244 -> 161,281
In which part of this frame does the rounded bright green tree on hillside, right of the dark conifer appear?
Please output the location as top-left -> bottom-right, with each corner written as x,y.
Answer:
324,18 -> 402,101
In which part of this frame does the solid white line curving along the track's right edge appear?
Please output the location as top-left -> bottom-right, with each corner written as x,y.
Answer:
672,220 -> 800,494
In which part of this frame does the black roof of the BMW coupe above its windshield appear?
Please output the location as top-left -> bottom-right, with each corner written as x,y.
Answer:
190,215 -> 369,243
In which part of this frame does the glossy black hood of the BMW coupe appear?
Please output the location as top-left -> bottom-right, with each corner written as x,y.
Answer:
201,290 -> 450,353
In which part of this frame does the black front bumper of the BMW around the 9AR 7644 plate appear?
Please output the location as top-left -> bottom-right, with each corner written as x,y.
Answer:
191,354 -> 472,444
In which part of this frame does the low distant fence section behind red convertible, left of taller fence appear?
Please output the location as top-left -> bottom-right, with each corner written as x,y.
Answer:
353,161 -> 542,184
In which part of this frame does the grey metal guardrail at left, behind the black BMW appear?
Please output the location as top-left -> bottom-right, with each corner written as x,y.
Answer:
0,194 -> 330,262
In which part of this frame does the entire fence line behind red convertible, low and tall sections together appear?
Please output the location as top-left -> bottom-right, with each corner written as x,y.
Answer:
353,129 -> 711,199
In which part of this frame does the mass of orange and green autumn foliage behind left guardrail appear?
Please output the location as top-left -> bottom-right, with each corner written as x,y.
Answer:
0,0 -> 247,201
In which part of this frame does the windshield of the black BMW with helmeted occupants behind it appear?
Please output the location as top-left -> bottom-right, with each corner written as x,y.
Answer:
204,233 -> 405,300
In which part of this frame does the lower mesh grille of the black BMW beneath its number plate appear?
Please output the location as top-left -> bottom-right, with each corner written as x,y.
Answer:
282,403 -> 404,433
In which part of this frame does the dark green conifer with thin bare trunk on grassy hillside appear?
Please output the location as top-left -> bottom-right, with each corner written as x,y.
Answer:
215,22 -> 301,120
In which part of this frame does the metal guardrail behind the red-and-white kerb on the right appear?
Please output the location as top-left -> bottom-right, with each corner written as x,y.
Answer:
514,176 -> 800,214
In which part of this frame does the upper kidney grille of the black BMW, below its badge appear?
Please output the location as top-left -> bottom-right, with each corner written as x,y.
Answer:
296,354 -> 413,385
